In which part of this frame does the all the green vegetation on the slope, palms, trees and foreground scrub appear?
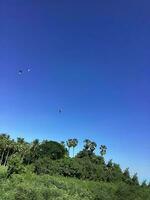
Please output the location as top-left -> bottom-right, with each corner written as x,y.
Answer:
0,134 -> 150,200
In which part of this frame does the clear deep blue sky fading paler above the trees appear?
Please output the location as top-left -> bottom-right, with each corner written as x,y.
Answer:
0,0 -> 150,180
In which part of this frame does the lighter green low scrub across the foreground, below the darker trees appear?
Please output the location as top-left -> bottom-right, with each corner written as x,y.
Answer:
0,173 -> 150,200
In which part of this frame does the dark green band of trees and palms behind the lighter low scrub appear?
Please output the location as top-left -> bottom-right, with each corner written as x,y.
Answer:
0,134 -> 150,188
